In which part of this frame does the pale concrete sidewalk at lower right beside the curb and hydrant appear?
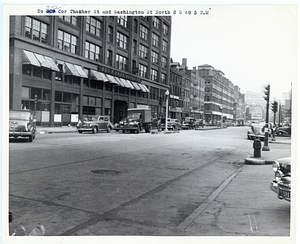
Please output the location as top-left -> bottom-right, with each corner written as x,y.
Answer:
178,135 -> 292,237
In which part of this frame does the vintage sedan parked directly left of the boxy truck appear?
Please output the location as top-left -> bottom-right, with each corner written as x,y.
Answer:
77,115 -> 114,133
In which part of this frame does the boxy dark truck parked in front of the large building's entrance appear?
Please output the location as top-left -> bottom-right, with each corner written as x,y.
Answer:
117,108 -> 152,134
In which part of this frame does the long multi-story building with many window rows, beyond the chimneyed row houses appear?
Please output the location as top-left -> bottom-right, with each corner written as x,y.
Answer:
198,64 -> 234,122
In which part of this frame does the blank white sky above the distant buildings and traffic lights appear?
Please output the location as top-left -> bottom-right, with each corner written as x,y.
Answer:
171,5 -> 297,99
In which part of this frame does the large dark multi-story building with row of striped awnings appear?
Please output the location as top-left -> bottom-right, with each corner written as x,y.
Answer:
9,16 -> 171,126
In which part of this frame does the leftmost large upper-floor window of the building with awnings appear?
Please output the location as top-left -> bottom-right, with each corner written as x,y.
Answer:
25,16 -> 48,44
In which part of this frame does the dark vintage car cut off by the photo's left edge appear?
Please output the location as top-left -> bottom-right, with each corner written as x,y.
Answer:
9,110 -> 36,142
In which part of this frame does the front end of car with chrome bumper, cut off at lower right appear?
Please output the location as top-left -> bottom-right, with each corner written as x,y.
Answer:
270,157 -> 291,202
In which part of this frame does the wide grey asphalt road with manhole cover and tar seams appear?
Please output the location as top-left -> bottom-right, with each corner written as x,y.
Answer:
9,127 -> 290,240
